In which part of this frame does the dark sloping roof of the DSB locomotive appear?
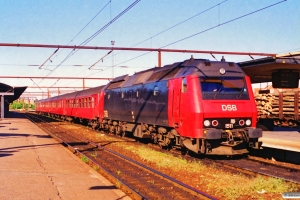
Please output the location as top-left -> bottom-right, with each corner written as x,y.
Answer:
106,58 -> 245,89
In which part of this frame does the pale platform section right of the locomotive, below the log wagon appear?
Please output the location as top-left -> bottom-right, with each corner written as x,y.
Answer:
259,131 -> 300,152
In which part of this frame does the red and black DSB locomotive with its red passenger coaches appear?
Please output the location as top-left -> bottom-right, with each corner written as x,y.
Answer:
36,57 -> 262,155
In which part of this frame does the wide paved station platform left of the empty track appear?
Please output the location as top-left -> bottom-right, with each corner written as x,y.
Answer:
0,112 -> 131,200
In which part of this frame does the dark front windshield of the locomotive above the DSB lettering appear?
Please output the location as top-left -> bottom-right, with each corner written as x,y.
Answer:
200,77 -> 249,100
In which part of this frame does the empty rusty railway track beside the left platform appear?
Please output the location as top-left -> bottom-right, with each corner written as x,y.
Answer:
26,113 -> 215,200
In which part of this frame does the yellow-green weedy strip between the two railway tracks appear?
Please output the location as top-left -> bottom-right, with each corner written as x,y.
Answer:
111,143 -> 299,199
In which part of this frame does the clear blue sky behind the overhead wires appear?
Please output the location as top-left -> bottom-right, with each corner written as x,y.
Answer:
0,0 -> 300,98
